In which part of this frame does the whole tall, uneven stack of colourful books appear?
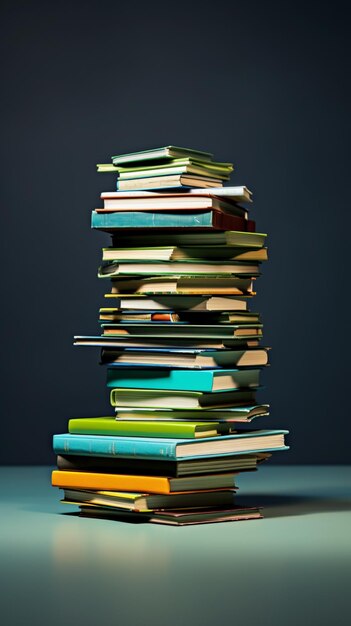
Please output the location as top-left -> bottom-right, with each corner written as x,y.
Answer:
52,146 -> 287,525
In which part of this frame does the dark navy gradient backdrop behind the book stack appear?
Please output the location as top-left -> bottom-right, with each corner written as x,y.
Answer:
0,0 -> 351,464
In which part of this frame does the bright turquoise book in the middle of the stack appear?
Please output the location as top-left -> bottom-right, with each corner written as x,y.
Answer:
107,367 -> 260,392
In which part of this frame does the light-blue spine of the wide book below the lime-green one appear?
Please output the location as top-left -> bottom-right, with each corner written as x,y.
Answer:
53,434 -> 176,460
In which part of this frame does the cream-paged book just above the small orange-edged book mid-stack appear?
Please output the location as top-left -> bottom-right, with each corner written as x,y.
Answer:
105,293 -> 247,312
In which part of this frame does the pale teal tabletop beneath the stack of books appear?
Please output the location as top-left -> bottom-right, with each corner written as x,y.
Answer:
0,465 -> 351,626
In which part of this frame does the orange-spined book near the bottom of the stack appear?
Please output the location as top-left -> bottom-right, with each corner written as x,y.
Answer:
52,470 -> 236,494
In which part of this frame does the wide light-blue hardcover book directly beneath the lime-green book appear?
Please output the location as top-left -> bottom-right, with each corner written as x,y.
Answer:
53,430 -> 288,460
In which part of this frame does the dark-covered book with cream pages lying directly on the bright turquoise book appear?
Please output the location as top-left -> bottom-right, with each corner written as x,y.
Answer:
101,348 -> 268,368
